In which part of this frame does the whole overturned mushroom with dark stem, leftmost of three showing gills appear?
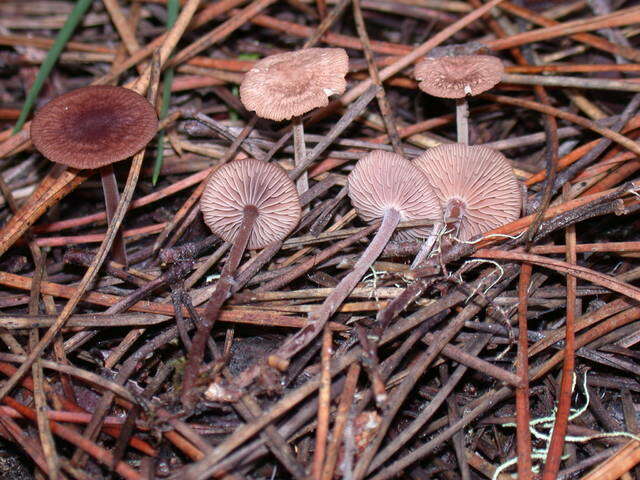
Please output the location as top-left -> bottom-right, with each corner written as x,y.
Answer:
182,158 -> 301,405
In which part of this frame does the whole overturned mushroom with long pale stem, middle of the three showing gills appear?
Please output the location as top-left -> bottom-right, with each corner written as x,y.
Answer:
269,151 -> 442,372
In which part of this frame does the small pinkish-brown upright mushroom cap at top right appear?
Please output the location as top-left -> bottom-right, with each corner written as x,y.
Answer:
414,55 -> 504,98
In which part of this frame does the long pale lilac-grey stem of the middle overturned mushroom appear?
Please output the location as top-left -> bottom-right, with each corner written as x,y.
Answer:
269,209 -> 400,365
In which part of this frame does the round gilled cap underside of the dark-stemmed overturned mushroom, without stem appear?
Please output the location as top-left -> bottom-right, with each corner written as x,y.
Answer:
200,158 -> 300,249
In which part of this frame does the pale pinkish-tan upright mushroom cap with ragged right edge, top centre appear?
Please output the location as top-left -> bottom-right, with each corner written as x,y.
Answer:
240,48 -> 349,121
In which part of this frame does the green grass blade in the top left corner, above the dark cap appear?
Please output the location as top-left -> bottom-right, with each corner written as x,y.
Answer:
13,0 -> 92,133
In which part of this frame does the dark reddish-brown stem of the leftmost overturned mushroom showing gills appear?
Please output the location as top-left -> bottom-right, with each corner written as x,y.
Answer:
182,205 -> 258,406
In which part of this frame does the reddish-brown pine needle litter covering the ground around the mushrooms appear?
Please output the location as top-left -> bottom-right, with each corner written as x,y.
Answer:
0,0 -> 640,480
